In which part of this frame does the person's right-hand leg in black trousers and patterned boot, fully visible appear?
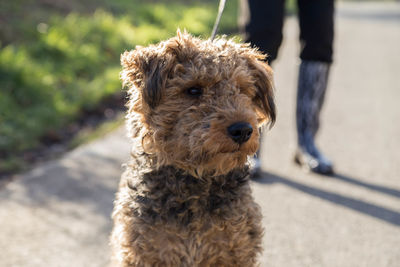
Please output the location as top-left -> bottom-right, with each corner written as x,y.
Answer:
295,0 -> 334,174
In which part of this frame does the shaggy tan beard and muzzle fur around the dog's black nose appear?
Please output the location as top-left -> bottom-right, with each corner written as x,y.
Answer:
153,113 -> 259,176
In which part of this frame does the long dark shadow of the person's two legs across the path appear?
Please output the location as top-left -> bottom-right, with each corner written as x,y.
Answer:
253,172 -> 400,226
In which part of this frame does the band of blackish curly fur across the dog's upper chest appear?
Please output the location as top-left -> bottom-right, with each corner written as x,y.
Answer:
129,167 -> 249,227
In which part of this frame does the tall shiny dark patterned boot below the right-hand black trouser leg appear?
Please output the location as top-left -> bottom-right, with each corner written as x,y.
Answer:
295,61 -> 333,175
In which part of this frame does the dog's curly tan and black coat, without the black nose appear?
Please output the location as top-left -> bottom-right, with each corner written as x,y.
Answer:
111,31 -> 275,267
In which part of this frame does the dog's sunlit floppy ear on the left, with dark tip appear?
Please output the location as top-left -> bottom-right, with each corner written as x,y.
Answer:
121,46 -> 168,108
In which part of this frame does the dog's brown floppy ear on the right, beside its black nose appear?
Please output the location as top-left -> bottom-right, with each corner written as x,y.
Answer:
250,58 -> 276,126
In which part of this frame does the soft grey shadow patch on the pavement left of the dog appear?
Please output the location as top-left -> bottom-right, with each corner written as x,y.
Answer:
0,153 -> 122,218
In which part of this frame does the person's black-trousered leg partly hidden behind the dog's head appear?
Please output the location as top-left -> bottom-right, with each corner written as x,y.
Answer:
239,0 -> 285,62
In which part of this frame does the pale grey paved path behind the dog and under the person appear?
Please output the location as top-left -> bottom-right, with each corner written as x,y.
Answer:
0,4 -> 400,267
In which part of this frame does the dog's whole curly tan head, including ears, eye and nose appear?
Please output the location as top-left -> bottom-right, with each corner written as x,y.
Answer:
121,32 -> 275,176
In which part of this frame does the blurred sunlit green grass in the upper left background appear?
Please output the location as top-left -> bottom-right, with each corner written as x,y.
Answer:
0,0 -> 237,173
